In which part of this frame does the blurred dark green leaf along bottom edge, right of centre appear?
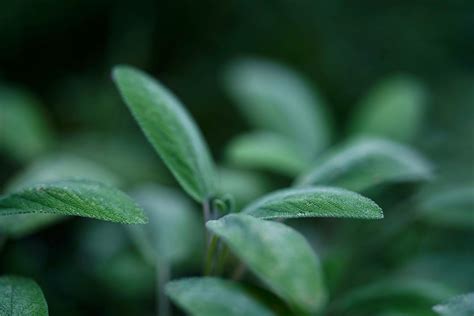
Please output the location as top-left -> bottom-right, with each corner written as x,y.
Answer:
331,277 -> 453,315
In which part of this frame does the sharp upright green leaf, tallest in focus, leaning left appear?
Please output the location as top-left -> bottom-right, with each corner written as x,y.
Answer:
113,66 -> 216,201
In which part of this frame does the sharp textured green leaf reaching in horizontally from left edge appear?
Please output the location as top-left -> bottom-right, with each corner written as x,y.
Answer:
0,180 -> 147,224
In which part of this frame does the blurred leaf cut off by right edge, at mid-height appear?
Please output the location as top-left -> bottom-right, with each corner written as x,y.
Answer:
421,186 -> 474,228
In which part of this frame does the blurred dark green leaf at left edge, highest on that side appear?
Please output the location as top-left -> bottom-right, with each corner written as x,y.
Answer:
0,87 -> 53,162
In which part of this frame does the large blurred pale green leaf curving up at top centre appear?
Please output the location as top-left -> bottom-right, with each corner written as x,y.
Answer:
226,59 -> 330,158
